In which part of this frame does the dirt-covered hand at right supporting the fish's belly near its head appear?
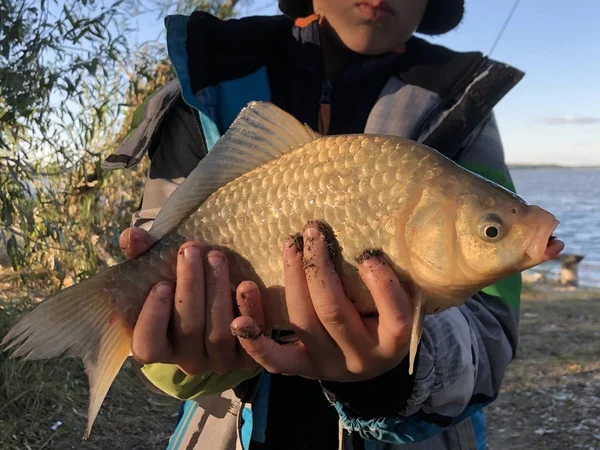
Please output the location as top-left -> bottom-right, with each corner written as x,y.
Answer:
232,223 -> 412,381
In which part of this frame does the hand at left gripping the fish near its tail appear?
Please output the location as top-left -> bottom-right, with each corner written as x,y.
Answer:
119,227 -> 264,375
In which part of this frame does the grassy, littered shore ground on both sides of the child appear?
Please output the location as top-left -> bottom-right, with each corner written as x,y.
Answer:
0,276 -> 600,450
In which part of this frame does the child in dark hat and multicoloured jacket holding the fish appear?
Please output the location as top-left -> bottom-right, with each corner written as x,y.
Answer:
105,0 -> 522,450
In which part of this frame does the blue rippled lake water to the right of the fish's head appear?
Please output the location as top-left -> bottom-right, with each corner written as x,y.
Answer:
511,168 -> 600,287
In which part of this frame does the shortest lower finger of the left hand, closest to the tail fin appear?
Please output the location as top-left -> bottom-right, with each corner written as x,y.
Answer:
131,282 -> 173,364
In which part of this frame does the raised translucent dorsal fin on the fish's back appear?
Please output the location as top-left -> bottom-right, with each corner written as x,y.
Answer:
150,102 -> 318,241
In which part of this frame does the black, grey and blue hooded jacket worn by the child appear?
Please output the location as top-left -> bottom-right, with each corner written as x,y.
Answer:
104,12 -> 523,450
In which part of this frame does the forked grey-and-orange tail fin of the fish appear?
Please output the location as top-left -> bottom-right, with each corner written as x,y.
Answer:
0,263 -> 132,439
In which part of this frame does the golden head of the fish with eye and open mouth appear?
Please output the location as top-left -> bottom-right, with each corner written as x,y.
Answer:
396,174 -> 564,302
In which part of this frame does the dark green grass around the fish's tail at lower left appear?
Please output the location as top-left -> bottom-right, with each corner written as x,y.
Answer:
0,285 -> 179,450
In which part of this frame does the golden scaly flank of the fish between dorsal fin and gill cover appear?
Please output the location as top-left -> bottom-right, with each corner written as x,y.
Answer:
177,136 -> 412,328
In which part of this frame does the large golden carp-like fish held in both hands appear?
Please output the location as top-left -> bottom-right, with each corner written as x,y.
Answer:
2,102 -> 564,438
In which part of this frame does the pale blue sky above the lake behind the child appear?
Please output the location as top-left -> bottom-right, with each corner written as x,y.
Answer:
134,0 -> 600,166
